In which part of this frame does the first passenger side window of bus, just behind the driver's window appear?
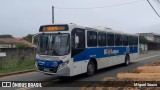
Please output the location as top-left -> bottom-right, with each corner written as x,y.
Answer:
87,31 -> 97,47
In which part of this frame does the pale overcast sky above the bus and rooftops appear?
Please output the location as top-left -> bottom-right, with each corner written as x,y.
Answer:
0,0 -> 160,37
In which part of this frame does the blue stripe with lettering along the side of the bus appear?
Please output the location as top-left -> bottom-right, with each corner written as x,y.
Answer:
73,46 -> 138,62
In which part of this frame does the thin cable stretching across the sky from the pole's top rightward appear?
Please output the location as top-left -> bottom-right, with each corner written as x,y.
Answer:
55,0 -> 145,9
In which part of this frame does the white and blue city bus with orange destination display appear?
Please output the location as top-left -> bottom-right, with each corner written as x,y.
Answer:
35,23 -> 139,77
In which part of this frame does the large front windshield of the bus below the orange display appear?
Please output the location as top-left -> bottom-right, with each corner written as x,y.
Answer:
37,33 -> 70,56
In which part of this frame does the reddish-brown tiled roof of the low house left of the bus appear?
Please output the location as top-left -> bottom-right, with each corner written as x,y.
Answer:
0,38 -> 36,47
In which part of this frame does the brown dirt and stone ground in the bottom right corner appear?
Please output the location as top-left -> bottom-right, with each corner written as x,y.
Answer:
80,61 -> 160,90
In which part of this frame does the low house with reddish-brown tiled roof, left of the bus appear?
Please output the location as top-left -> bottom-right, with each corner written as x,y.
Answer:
0,38 -> 36,48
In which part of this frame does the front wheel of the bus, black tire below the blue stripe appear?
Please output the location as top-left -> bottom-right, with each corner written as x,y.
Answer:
87,61 -> 96,76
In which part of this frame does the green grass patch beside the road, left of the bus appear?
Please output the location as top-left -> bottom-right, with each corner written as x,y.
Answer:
0,58 -> 34,74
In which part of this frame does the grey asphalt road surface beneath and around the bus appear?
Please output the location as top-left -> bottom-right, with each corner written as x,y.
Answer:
0,51 -> 160,90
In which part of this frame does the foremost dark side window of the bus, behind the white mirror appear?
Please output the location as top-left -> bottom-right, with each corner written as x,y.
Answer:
71,28 -> 85,49
